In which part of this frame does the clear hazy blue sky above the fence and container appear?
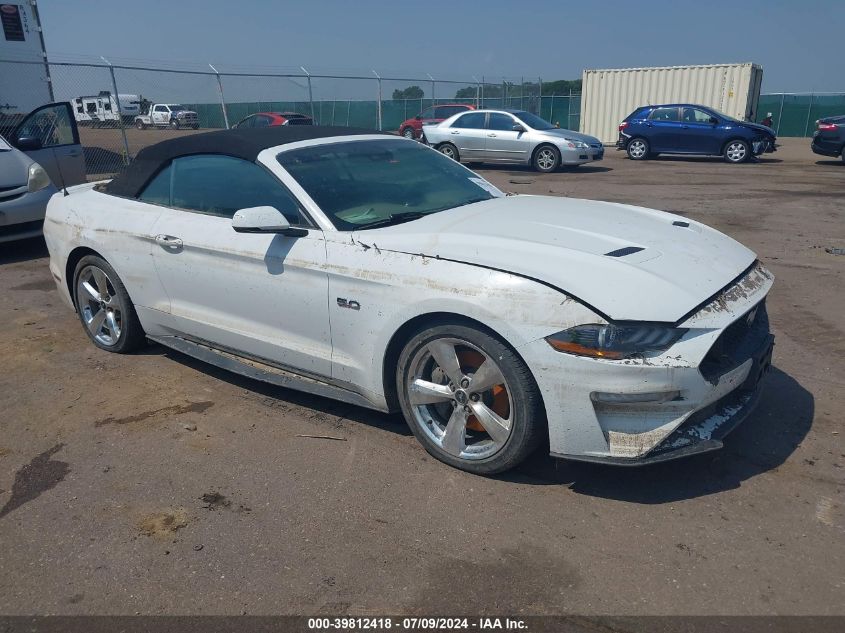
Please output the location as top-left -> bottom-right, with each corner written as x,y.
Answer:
38,0 -> 845,96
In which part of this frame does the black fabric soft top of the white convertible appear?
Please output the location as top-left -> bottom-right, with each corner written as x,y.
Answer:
102,125 -> 392,198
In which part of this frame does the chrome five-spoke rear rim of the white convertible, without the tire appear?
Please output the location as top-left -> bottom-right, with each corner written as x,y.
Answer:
76,266 -> 124,347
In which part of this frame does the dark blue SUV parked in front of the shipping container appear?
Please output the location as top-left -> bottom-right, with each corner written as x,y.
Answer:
616,103 -> 776,163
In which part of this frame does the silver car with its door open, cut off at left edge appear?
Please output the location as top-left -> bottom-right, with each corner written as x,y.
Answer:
0,103 -> 85,242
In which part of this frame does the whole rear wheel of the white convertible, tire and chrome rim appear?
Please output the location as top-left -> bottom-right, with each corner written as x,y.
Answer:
73,255 -> 146,354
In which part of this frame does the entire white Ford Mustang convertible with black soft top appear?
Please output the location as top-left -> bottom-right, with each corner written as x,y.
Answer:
44,126 -> 773,474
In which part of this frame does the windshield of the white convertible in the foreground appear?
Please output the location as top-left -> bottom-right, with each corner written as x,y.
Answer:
277,139 -> 504,231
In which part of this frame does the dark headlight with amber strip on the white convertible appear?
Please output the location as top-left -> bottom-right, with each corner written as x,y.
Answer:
546,323 -> 687,360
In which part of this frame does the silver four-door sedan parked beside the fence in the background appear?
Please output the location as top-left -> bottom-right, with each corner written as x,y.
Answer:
425,110 -> 604,172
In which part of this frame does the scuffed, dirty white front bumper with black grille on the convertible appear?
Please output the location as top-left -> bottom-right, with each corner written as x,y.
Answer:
519,262 -> 774,466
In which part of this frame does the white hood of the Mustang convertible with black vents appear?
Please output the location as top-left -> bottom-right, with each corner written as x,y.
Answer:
355,195 -> 755,323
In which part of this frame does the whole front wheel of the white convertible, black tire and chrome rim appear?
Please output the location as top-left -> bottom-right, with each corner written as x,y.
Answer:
396,323 -> 545,475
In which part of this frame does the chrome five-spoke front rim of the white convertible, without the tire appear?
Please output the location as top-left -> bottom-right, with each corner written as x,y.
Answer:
406,338 -> 514,460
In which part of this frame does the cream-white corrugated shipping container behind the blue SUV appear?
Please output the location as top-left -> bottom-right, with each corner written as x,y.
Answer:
580,62 -> 763,143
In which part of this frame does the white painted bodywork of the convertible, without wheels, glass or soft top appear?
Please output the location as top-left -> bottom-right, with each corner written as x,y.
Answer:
45,136 -> 773,461
